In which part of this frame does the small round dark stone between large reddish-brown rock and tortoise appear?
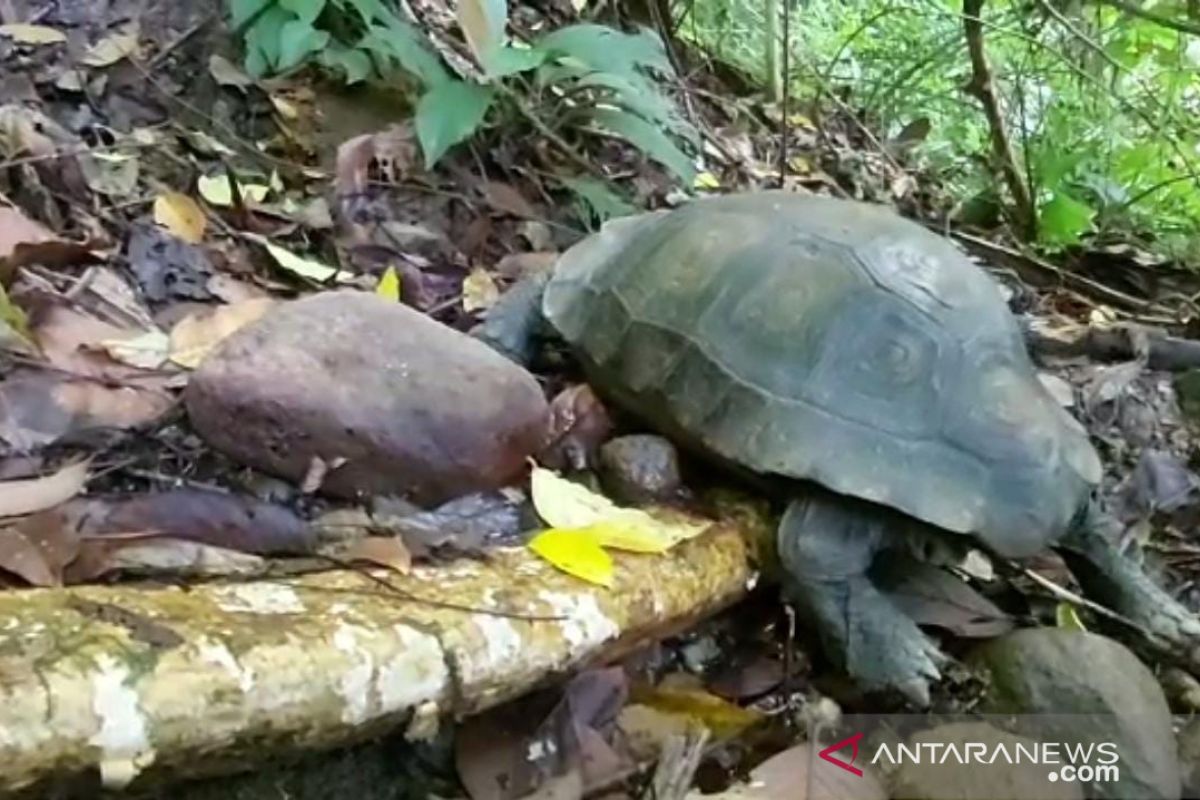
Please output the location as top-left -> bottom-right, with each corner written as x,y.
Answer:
600,434 -> 683,504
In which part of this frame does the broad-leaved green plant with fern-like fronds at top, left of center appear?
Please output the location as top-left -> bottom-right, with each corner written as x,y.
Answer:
229,0 -> 698,216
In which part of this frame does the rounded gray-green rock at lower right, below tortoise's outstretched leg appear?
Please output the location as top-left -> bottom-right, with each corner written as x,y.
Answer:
973,628 -> 1181,799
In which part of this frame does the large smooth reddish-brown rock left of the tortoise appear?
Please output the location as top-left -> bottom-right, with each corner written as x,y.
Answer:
185,291 -> 547,505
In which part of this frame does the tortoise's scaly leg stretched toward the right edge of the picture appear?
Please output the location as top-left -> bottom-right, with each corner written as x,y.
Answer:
1055,504 -> 1200,670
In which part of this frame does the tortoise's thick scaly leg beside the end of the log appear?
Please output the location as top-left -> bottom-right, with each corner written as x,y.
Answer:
778,492 -> 944,708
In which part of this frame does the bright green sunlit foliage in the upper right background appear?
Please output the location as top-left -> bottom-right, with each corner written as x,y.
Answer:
677,0 -> 1200,257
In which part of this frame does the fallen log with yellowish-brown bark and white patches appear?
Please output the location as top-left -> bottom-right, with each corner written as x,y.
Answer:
0,516 -> 762,796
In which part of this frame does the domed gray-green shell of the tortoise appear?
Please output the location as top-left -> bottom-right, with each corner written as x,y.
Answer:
542,192 -> 1100,557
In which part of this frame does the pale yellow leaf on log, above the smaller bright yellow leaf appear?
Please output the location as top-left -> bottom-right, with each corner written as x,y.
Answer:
529,467 -> 709,553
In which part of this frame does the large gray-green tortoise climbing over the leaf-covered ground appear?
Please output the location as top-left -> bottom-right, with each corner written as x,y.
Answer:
476,191 -> 1200,705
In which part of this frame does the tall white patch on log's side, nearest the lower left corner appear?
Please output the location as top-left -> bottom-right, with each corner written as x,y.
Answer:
88,654 -> 154,788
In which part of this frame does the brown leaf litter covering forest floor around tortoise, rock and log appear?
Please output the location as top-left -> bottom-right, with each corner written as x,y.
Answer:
0,0 -> 1200,800
